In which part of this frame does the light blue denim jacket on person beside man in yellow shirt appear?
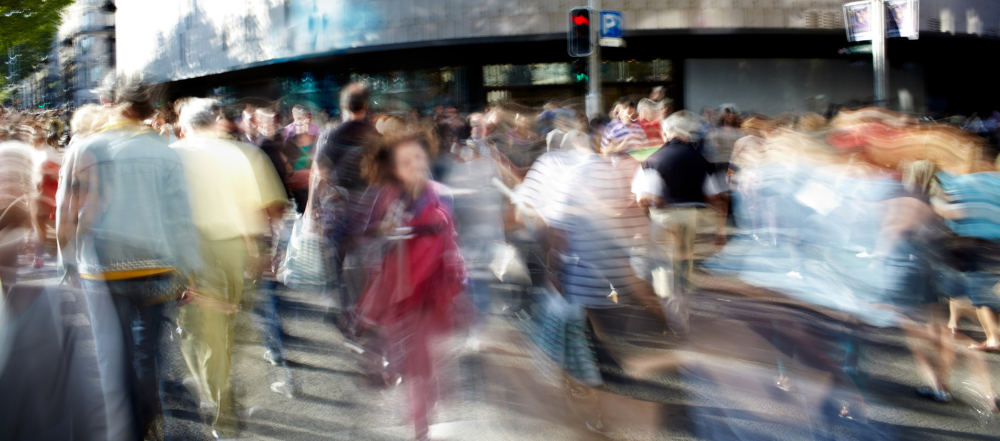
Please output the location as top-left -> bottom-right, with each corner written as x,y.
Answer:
56,126 -> 201,275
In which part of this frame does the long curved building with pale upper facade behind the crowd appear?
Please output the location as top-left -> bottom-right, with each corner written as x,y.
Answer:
116,0 -> 1000,113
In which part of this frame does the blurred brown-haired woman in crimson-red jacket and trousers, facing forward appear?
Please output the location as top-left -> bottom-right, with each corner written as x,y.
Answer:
358,131 -> 466,439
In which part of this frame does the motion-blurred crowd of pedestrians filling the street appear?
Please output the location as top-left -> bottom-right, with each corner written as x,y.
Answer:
0,76 -> 1000,440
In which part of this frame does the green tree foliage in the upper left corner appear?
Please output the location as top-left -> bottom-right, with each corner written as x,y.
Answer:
0,0 -> 73,87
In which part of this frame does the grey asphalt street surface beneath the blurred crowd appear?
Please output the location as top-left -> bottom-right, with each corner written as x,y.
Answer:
11,237 -> 1000,441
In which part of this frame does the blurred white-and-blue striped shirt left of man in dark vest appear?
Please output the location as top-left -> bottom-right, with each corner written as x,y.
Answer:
515,152 -> 649,308
